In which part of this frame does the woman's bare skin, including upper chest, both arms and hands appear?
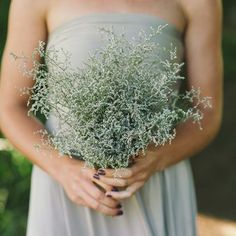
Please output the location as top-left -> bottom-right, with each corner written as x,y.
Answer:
0,0 -> 223,216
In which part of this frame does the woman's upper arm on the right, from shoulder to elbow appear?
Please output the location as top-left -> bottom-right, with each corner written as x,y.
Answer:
182,0 -> 223,124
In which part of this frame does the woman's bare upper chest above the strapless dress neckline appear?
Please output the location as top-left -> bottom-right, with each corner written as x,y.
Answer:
46,0 -> 186,33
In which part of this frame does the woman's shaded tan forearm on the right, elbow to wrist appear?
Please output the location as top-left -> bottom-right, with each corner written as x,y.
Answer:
150,109 -> 221,171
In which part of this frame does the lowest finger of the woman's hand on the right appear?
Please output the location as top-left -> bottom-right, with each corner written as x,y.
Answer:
106,182 -> 144,200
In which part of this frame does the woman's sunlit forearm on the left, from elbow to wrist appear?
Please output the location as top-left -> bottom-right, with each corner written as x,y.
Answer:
0,106 -> 66,181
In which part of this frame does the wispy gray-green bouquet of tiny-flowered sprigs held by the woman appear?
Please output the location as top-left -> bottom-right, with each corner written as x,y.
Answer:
12,26 -> 210,169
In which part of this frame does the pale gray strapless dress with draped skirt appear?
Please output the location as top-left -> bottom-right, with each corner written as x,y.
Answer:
27,12 -> 197,236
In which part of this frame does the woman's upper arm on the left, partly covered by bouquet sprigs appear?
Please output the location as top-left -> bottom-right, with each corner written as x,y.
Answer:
0,0 -> 47,109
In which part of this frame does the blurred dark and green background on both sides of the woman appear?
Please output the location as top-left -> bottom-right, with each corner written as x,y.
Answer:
0,0 -> 236,236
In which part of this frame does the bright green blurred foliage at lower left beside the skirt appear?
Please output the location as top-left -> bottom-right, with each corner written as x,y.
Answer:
0,139 -> 31,236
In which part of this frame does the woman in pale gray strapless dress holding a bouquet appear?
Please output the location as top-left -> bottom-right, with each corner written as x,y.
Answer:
0,0 -> 222,236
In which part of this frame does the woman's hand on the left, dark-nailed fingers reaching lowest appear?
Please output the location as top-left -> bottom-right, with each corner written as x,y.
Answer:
56,157 -> 123,216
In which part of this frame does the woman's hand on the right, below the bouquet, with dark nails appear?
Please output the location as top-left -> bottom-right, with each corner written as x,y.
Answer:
95,149 -> 158,200
